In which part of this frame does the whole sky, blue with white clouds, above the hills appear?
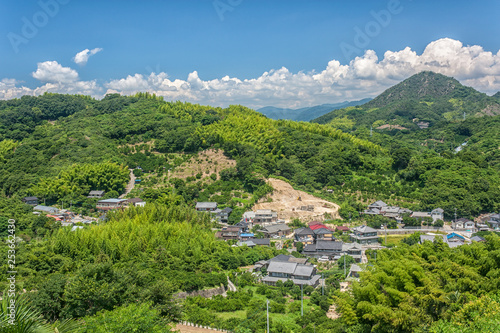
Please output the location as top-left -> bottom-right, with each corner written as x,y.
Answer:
0,0 -> 500,107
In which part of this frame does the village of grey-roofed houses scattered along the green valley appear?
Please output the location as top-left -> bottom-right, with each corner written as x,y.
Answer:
19,191 -> 500,288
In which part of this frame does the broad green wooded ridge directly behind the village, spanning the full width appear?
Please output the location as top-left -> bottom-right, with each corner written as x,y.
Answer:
0,93 -> 500,221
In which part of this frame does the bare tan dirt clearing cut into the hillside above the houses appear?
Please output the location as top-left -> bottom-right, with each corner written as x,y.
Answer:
253,178 -> 340,222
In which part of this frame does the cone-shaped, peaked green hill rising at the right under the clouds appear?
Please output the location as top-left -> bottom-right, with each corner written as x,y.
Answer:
312,72 -> 500,131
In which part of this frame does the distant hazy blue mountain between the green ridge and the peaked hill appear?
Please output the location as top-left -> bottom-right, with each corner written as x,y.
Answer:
257,98 -> 371,121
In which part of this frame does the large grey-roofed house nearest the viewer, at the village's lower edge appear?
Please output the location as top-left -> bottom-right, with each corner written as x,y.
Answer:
262,260 -> 320,287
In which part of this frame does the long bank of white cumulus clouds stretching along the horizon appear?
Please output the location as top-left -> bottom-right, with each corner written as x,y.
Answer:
0,38 -> 500,108
